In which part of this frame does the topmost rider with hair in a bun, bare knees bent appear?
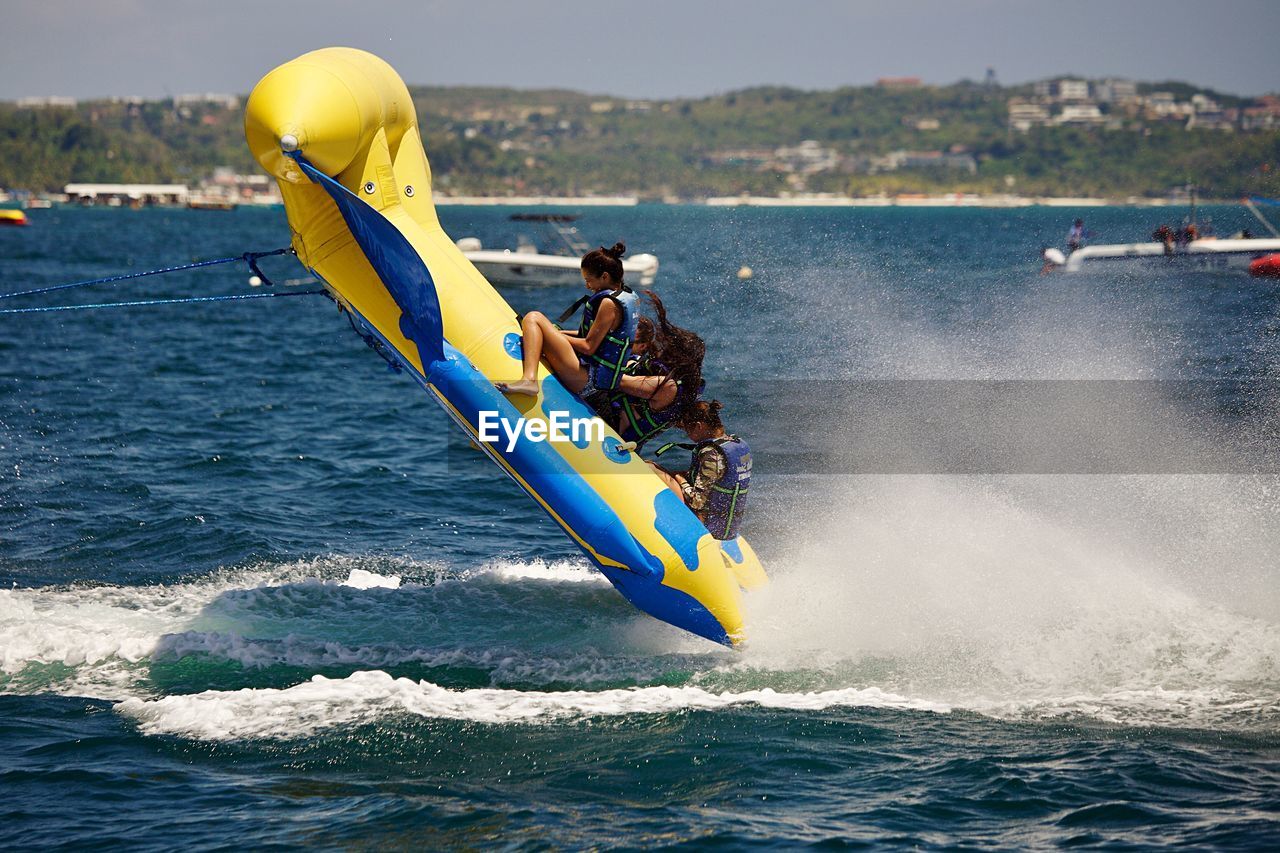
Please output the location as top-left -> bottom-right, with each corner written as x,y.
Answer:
494,243 -> 636,396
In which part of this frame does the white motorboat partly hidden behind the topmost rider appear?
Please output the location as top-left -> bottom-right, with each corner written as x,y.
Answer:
457,214 -> 658,287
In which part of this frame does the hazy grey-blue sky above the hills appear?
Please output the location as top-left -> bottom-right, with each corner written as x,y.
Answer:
0,0 -> 1280,100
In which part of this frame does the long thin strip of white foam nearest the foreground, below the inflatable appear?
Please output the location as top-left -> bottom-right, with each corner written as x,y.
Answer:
116,671 -> 950,740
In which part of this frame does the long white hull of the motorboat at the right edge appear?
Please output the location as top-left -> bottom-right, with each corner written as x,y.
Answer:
1044,237 -> 1280,273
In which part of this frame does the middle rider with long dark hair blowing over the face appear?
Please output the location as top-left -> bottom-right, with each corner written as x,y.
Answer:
605,291 -> 707,450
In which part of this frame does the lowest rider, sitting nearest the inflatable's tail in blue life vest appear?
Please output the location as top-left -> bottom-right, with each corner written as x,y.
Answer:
649,400 -> 751,539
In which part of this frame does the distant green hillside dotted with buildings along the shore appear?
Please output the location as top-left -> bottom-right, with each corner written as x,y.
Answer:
0,82 -> 1280,199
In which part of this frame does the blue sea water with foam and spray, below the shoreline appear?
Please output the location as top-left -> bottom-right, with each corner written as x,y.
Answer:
0,205 -> 1280,849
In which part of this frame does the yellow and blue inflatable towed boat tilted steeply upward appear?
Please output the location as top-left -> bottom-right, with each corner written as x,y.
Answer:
244,47 -> 767,644
